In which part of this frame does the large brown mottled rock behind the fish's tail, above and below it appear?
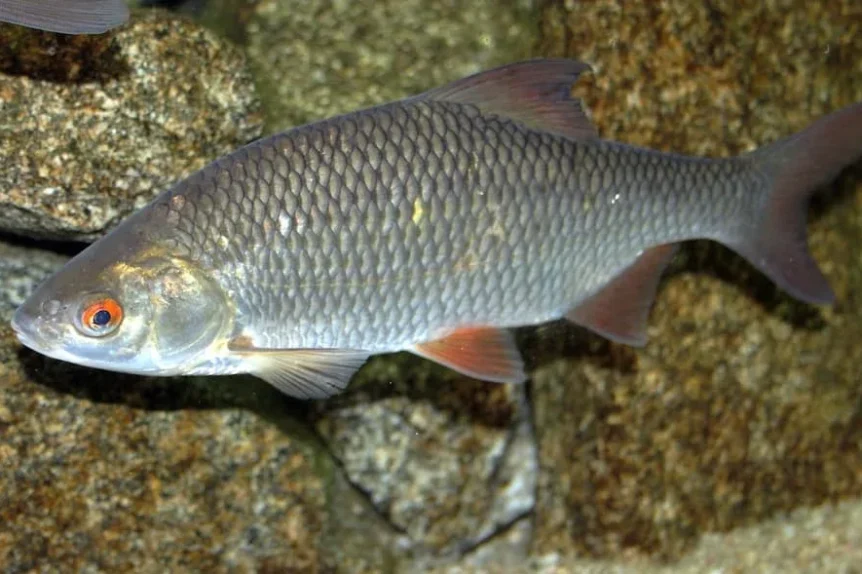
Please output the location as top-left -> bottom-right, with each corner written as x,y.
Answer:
531,0 -> 862,559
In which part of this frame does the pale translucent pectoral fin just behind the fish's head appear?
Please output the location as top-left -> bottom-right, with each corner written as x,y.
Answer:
228,342 -> 370,399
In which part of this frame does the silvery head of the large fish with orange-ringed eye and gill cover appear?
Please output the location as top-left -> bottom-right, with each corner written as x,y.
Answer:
12,236 -> 232,376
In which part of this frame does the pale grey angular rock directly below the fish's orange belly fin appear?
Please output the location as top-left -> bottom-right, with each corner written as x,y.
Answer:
316,356 -> 537,555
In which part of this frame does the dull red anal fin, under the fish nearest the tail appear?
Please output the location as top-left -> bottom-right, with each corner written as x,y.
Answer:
566,243 -> 677,347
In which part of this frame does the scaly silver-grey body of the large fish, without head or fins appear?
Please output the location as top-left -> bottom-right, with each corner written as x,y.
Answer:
149,99 -> 760,352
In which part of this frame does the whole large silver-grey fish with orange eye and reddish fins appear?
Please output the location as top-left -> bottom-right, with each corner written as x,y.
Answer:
12,59 -> 862,399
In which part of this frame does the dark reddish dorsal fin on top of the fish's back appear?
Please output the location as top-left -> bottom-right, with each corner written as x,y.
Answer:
419,59 -> 598,140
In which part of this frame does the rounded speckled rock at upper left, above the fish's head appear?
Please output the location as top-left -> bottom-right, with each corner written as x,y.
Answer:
0,11 -> 261,241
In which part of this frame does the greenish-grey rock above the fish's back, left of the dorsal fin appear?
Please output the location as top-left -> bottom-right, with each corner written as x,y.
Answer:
245,0 -> 537,132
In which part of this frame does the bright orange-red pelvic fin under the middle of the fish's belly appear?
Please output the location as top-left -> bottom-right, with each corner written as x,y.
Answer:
411,327 -> 527,383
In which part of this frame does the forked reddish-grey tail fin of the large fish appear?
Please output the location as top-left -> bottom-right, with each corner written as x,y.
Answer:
724,102 -> 862,304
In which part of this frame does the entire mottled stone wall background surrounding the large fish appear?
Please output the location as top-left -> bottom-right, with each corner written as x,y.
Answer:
0,0 -> 862,572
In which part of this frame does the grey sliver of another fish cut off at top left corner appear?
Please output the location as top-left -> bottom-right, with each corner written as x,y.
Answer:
0,0 -> 129,34
